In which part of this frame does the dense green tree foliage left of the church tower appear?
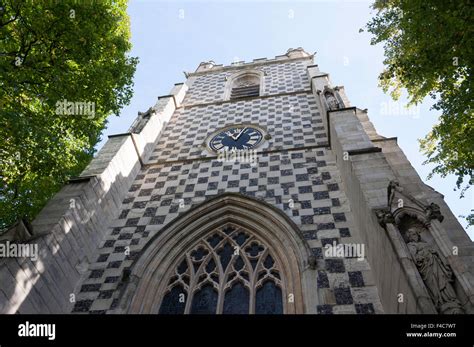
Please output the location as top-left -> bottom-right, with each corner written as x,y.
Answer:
0,0 -> 137,229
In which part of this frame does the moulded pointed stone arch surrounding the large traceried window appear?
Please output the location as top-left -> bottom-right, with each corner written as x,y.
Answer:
117,193 -> 317,314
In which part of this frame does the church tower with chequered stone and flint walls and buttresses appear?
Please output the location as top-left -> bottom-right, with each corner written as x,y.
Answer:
0,48 -> 474,314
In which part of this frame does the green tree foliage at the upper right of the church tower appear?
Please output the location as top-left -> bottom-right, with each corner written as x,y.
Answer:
367,0 -> 474,225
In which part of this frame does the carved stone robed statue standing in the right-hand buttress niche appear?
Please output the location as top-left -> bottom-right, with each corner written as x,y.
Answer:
405,226 -> 464,314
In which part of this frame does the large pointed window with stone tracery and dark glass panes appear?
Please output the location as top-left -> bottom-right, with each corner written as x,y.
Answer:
159,224 -> 285,314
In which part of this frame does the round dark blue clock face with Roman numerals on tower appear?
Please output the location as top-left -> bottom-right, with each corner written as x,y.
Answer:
209,125 -> 263,151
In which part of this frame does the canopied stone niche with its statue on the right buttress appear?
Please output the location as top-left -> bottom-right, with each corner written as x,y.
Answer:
376,181 -> 473,314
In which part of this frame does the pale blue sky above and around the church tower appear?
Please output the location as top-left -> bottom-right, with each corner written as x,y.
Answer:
98,0 -> 474,239
